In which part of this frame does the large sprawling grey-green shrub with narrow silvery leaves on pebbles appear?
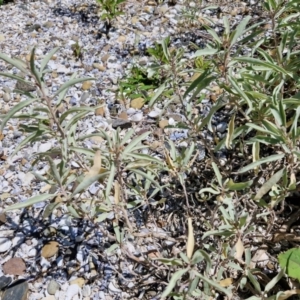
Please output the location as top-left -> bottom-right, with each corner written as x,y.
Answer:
0,0 -> 300,300
